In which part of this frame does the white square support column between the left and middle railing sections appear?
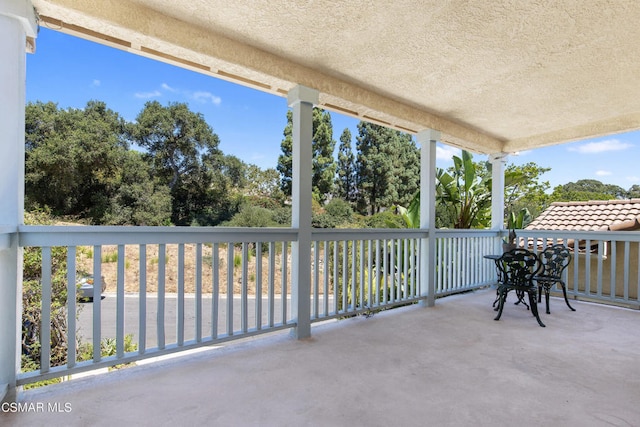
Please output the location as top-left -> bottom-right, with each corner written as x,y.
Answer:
283,86 -> 319,339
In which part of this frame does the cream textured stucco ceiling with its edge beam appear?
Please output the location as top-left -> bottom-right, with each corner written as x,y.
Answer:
33,0 -> 640,153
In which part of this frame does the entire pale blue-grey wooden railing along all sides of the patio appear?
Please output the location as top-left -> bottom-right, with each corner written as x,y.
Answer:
10,226 -> 640,384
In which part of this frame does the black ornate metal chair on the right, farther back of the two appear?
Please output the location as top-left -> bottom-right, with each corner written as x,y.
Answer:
533,244 -> 576,314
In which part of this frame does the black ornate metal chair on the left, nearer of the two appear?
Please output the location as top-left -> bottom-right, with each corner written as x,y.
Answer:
494,248 -> 545,327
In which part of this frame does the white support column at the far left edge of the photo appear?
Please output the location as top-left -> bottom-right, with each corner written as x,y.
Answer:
0,0 -> 37,401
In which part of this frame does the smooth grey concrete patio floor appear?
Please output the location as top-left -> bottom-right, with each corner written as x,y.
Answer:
5,289 -> 640,427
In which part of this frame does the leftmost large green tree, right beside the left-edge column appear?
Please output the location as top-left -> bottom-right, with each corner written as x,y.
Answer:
25,101 -> 128,223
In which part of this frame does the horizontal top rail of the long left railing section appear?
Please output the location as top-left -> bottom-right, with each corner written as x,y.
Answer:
18,226 -> 298,246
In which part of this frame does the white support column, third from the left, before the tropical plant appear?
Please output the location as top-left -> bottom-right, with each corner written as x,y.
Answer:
416,129 -> 440,307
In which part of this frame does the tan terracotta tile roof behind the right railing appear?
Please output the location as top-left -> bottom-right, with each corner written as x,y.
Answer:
526,199 -> 640,231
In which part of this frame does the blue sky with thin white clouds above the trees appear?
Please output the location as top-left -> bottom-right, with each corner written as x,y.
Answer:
27,28 -> 640,189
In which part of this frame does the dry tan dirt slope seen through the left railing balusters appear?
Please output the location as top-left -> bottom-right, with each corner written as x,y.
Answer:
76,244 -> 291,295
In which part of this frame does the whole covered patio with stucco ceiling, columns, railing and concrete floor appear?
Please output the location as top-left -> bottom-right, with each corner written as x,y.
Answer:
0,0 -> 640,426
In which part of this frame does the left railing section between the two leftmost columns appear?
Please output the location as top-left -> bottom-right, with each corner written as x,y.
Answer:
18,226 -> 296,384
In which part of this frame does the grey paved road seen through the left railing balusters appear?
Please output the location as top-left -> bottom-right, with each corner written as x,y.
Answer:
77,294 -> 290,348
